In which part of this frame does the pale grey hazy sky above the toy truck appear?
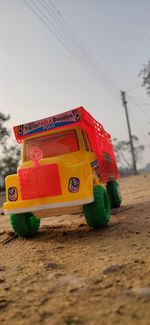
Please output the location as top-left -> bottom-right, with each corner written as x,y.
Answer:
0,0 -> 150,166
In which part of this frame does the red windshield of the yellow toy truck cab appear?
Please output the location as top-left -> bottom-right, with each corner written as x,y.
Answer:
24,130 -> 79,161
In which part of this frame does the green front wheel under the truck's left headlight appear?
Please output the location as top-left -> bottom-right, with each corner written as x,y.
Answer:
10,212 -> 40,237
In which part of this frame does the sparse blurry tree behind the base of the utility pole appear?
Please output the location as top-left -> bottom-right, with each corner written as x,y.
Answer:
113,135 -> 145,174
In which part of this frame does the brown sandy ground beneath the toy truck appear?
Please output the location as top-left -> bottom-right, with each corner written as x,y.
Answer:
0,174 -> 150,325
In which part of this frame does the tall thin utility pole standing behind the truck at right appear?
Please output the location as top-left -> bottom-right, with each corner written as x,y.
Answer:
121,91 -> 137,175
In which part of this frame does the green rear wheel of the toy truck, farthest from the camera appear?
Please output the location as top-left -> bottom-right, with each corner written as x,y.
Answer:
107,181 -> 122,209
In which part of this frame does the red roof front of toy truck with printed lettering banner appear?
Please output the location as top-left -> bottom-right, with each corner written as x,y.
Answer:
13,106 -> 110,143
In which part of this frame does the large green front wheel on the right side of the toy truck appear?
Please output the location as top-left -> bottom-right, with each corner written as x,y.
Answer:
83,185 -> 110,228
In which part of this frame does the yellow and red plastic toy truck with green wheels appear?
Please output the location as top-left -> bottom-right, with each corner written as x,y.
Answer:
4,107 -> 121,237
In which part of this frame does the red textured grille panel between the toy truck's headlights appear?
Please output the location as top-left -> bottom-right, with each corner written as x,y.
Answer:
18,164 -> 62,200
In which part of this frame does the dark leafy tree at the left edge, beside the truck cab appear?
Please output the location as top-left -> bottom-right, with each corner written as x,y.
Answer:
0,113 -> 21,190
